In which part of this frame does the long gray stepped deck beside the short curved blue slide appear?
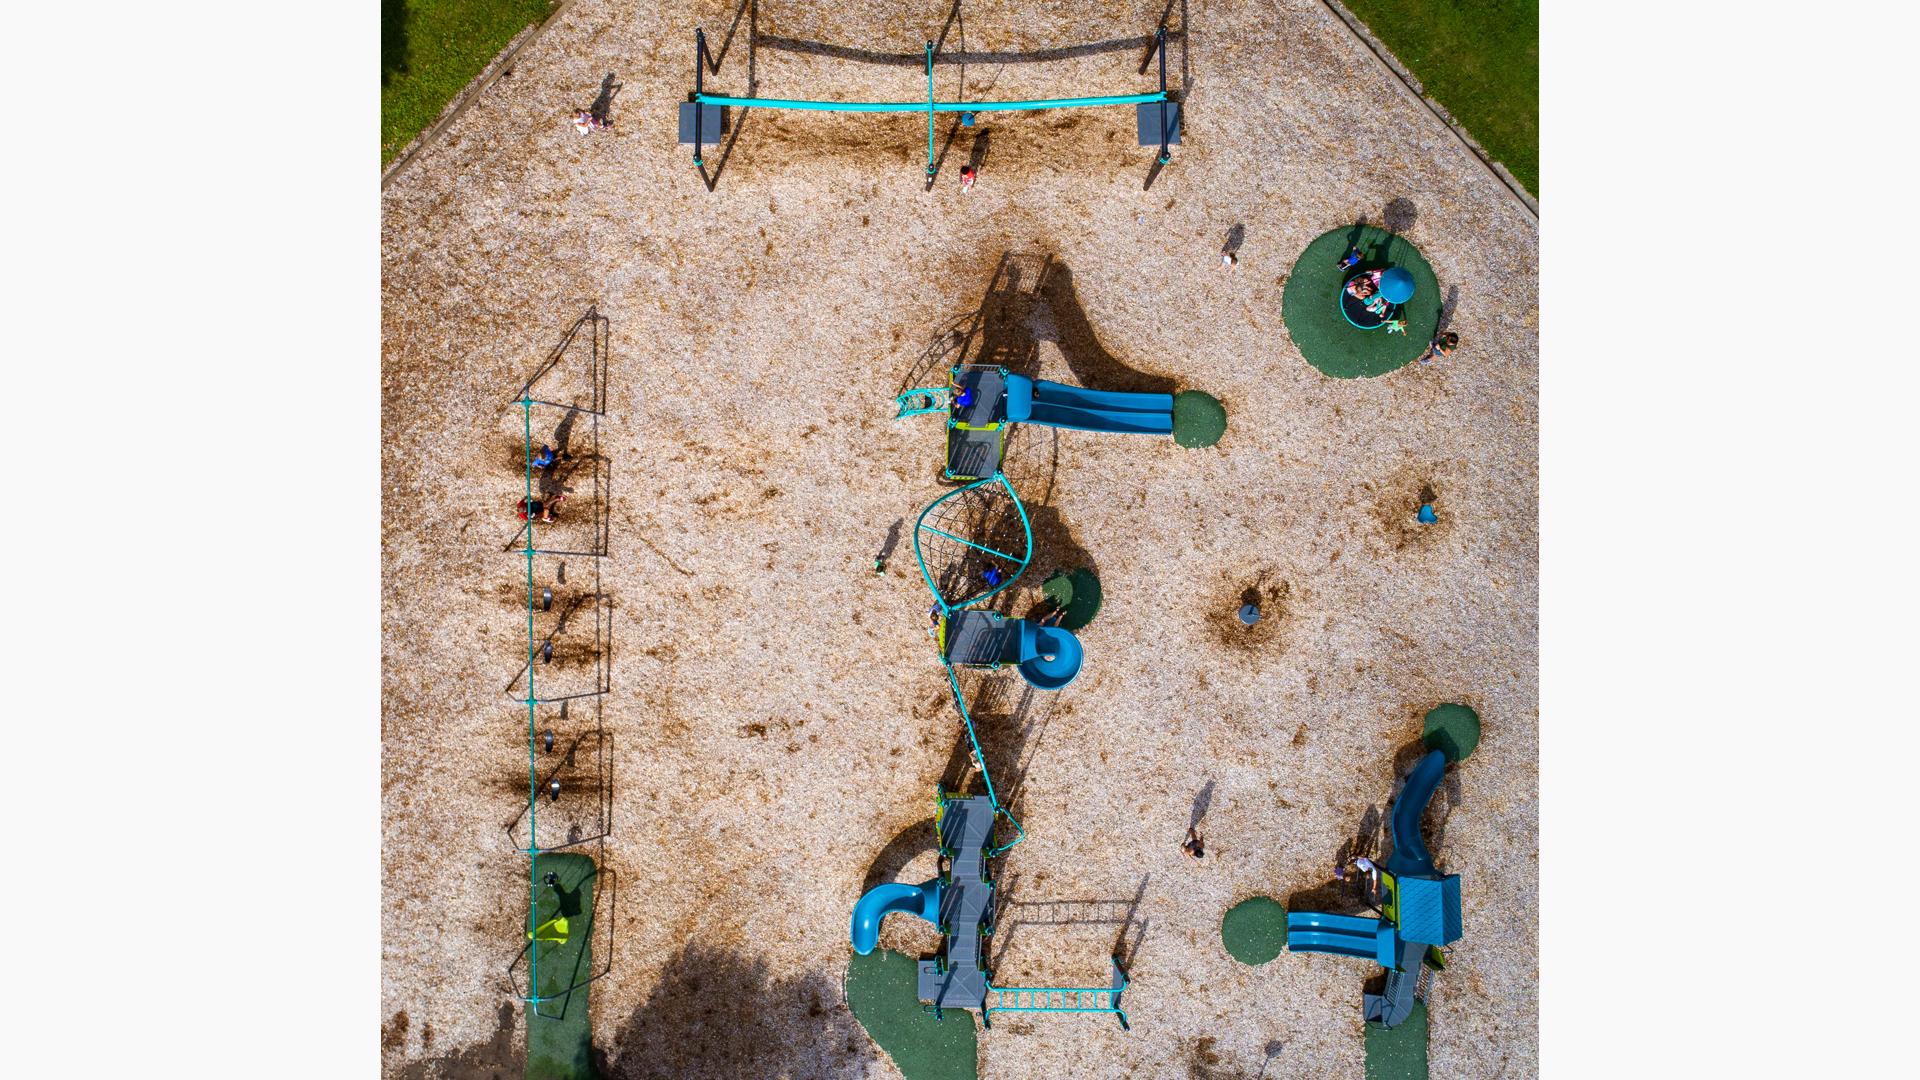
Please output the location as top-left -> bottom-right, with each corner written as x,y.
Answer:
918,796 -> 993,1009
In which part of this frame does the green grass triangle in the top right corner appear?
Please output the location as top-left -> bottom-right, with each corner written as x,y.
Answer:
1342,0 -> 1540,198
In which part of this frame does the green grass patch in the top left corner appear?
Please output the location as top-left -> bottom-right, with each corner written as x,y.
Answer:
380,0 -> 553,169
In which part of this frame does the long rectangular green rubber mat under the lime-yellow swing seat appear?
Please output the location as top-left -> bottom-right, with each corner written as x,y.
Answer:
520,851 -> 599,1080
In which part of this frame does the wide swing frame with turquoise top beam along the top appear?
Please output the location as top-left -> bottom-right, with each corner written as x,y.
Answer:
680,25 -> 1181,186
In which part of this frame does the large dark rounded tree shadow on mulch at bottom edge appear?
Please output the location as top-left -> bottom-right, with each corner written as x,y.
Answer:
595,945 -> 877,1080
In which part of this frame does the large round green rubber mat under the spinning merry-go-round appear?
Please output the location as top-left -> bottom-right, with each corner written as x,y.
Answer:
1281,225 -> 1444,379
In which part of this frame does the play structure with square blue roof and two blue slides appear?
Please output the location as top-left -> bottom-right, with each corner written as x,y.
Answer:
1286,749 -> 1461,1028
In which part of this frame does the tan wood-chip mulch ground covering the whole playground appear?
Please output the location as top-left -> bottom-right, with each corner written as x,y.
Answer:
382,0 -> 1538,1080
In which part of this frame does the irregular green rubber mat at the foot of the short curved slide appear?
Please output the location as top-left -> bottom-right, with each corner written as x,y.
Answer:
847,949 -> 979,1080
